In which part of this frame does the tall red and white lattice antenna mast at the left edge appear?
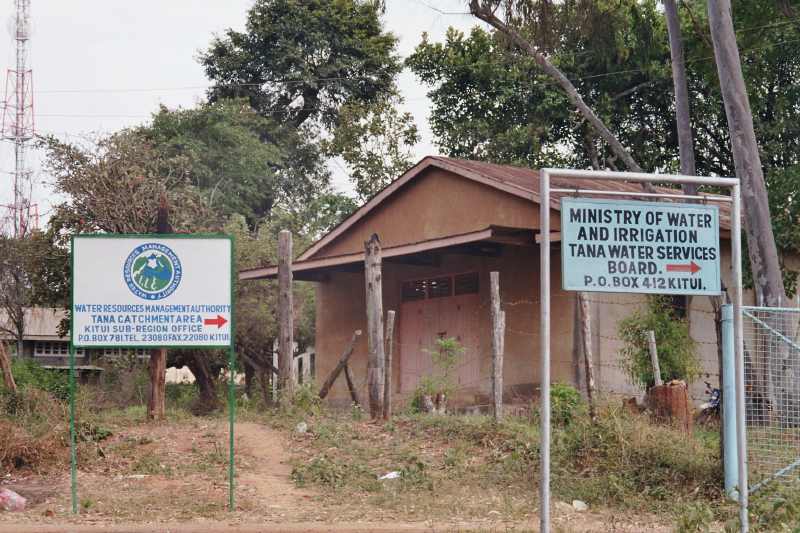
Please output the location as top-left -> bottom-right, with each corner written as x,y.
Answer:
2,0 -> 35,237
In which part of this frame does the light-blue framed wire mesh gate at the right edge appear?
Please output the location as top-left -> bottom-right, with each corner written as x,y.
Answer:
742,307 -> 800,491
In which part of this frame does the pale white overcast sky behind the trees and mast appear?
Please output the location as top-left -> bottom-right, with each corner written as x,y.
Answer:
0,0 -> 476,220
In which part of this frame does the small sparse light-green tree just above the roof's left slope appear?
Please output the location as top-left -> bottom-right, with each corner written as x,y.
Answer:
323,95 -> 420,202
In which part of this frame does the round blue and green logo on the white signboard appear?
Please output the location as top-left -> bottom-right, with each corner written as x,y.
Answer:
123,242 -> 183,300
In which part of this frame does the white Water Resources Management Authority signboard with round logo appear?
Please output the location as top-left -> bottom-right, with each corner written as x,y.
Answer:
72,235 -> 233,348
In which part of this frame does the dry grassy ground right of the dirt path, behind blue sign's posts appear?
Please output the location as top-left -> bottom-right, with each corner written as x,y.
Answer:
276,408 -> 752,530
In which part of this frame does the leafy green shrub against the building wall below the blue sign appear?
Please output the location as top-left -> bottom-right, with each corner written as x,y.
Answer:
619,296 -> 701,388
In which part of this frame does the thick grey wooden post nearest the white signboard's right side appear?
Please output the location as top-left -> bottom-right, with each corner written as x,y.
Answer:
278,229 -> 294,404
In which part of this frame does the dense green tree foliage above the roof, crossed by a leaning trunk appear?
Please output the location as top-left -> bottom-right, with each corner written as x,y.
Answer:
407,0 -> 675,170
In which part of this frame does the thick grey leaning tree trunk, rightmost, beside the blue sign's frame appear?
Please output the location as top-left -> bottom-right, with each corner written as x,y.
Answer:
708,0 -> 786,307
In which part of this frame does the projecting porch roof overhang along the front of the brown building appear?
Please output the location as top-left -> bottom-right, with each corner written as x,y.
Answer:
239,226 -> 534,280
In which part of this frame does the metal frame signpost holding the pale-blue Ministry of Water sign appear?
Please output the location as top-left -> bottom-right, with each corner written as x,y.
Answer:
539,169 -> 748,533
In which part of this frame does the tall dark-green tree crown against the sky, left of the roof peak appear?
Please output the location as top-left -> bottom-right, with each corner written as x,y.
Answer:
200,0 -> 400,129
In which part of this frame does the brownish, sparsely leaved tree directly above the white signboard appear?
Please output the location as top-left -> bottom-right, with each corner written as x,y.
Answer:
41,130 -> 218,236
